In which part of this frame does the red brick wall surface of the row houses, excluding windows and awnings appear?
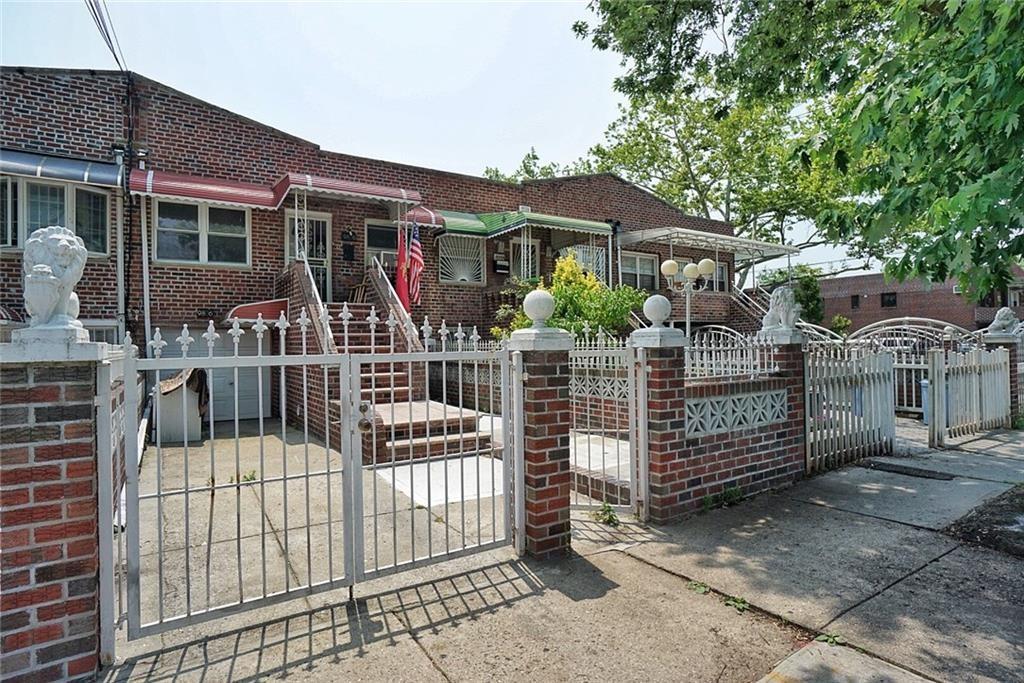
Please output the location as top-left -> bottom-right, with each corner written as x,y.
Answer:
0,68 -> 731,338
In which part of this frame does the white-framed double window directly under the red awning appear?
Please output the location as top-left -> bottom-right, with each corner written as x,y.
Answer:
154,200 -> 250,265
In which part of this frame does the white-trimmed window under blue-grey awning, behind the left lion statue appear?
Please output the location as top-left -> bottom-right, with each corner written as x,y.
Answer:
0,175 -> 110,254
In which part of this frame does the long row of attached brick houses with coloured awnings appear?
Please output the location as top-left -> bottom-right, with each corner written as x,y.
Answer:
0,68 -> 790,341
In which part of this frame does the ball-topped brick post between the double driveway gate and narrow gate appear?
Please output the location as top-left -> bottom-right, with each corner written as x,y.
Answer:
509,290 -> 572,557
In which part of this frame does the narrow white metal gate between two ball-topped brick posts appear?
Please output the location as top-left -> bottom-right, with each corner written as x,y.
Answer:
569,334 -> 649,519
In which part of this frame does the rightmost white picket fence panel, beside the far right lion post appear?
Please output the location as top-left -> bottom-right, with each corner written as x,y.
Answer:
928,348 -> 1011,447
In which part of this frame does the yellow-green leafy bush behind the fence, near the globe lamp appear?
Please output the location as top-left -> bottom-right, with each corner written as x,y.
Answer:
490,253 -> 646,339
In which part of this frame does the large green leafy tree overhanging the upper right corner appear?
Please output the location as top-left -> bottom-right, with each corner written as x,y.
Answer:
574,0 -> 1024,296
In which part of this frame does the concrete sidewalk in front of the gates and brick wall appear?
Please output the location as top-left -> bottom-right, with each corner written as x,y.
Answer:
106,423 -> 1024,683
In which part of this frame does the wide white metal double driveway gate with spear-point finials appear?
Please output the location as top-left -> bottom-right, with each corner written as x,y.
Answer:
119,309 -> 524,639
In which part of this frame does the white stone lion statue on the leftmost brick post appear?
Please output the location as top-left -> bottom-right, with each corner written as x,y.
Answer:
22,225 -> 88,328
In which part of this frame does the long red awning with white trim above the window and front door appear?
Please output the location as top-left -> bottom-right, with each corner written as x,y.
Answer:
128,169 -> 423,209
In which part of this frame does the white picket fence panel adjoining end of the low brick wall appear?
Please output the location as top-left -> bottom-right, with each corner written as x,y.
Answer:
806,345 -> 896,473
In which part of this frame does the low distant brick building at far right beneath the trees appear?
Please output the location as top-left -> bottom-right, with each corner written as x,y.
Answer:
821,266 -> 1024,330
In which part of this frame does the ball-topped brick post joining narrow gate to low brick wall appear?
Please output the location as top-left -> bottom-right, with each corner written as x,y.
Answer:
630,294 -> 689,523
